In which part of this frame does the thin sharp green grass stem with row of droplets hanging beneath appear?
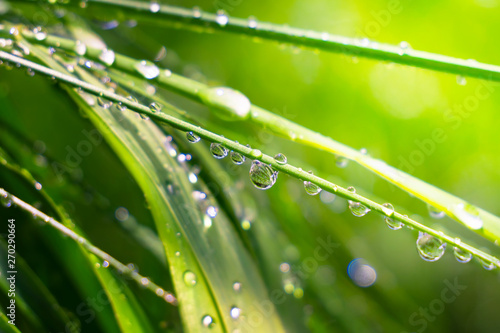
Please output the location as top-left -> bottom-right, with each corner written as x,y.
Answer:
0,51 -> 500,267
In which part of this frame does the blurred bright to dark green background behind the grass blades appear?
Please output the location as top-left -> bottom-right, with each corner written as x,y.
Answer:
0,0 -> 500,332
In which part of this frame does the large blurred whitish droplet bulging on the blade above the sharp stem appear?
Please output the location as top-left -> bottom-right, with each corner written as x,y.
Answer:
198,87 -> 252,120
